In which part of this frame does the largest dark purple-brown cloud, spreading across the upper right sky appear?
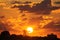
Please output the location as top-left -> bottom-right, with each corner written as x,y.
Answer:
13,0 -> 60,14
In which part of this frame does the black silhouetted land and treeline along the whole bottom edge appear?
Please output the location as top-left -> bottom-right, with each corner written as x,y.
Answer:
0,31 -> 60,40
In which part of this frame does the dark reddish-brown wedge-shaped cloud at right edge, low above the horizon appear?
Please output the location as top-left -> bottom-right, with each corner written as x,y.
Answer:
44,22 -> 60,32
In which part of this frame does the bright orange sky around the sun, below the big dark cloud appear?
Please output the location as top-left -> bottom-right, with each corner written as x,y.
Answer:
0,0 -> 60,37
